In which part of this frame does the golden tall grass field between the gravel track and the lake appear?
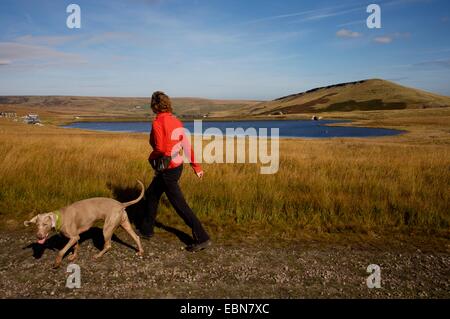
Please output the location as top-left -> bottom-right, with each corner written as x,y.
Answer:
0,108 -> 450,237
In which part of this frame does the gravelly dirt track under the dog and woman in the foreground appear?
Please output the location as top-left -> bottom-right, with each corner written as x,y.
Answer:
0,229 -> 450,298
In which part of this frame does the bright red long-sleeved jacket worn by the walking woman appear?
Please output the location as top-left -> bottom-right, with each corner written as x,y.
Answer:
149,112 -> 202,173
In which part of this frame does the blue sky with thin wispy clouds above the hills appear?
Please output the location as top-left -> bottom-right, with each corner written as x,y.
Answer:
0,0 -> 450,100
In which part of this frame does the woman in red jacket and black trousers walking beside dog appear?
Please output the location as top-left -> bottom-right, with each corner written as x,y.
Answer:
141,91 -> 211,251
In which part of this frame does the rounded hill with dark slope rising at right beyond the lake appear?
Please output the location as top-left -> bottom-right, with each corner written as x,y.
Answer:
243,79 -> 450,115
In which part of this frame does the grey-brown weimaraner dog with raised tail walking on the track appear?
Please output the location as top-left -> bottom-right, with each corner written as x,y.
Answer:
24,180 -> 144,268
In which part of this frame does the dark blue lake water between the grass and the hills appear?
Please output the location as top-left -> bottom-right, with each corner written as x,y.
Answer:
63,120 -> 403,138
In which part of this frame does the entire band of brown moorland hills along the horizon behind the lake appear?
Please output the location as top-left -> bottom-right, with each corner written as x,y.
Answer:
0,79 -> 450,120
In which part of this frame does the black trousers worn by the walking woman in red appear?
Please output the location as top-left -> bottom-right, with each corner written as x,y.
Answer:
141,165 -> 209,243
